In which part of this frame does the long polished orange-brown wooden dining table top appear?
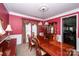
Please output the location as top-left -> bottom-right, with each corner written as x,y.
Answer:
38,37 -> 73,56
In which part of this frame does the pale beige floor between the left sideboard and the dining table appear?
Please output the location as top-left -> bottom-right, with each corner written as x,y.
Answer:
16,44 -> 36,56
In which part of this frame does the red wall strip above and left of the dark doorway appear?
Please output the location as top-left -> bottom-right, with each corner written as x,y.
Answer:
48,12 -> 79,37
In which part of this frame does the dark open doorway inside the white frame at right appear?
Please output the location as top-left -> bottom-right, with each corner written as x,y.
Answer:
62,15 -> 77,49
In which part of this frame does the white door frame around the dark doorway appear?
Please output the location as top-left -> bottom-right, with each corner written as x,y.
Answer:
61,14 -> 78,48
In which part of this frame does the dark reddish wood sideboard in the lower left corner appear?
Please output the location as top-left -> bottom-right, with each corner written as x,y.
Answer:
0,39 -> 16,56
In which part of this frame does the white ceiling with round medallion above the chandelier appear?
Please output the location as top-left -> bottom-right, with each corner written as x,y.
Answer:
4,3 -> 79,19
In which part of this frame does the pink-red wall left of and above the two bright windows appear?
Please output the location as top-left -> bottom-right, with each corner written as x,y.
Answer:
9,15 -> 40,34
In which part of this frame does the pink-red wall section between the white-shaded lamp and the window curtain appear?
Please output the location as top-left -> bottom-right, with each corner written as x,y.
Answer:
9,15 -> 22,34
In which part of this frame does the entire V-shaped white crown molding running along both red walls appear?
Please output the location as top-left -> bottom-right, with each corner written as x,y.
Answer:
9,8 -> 79,21
